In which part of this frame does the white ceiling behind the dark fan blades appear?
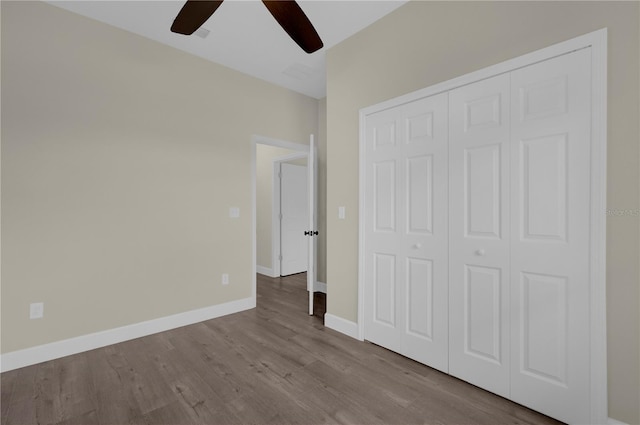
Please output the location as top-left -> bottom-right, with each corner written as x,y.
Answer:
48,0 -> 406,99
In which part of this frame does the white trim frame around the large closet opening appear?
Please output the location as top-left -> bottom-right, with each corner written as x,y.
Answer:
358,28 -> 608,424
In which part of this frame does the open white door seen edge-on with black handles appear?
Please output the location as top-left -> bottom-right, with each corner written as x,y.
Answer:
307,134 -> 318,316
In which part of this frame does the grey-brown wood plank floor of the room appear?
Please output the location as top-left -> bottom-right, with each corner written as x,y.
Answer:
1,274 -> 558,425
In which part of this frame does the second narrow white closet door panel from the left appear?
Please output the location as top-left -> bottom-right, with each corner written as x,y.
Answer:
401,93 -> 449,372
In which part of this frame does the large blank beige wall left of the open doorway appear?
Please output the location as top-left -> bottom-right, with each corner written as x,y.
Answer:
1,1 -> 318,353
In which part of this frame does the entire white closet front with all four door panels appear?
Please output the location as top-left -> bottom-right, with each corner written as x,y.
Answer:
360,35 -> 594,423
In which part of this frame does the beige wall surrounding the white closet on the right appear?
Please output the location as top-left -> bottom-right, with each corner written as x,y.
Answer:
327,2 -> 640,424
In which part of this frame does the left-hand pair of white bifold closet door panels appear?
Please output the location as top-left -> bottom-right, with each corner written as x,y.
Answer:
364,93 -> 448,371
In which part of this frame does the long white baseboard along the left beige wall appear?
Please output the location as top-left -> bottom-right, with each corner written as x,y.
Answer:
0,297 -> 256,372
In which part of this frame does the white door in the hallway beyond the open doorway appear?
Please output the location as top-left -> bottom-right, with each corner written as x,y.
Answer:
280,163 -> 309,276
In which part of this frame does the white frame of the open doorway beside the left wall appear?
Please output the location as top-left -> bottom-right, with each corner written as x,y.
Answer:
251,134 -> 309,298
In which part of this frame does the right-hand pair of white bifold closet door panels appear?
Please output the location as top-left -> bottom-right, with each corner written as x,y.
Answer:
449,49 -> 591,423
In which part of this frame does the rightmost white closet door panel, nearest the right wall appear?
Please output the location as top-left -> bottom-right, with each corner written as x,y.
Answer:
510,49 -> 591,423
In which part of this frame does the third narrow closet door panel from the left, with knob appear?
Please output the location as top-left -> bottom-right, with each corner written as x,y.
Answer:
449,74 -> 510,397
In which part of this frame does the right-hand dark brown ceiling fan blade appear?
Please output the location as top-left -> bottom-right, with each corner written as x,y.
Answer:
262,0 -> 324,53
